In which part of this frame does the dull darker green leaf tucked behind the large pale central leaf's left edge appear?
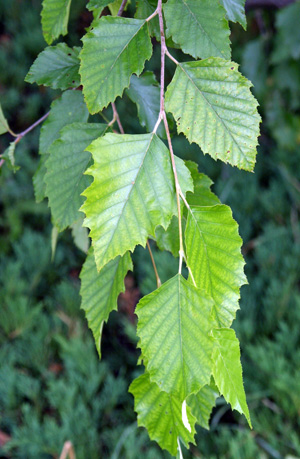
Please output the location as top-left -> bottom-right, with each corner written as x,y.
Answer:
45,123 -> 107,231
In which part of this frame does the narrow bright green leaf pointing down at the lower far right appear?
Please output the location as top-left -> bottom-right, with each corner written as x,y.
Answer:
213,328 -> 252,428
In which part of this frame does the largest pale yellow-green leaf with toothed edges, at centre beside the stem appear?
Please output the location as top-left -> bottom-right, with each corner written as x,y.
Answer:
81,134 -> 193,270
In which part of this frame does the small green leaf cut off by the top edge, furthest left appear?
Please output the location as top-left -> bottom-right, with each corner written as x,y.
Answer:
41,0 -> 71,45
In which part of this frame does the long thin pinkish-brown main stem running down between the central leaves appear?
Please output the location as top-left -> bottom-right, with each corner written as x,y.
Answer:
153,0 -> 185,274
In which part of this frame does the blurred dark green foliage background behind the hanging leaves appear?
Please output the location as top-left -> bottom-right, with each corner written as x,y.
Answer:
0,0 -> 300,459
